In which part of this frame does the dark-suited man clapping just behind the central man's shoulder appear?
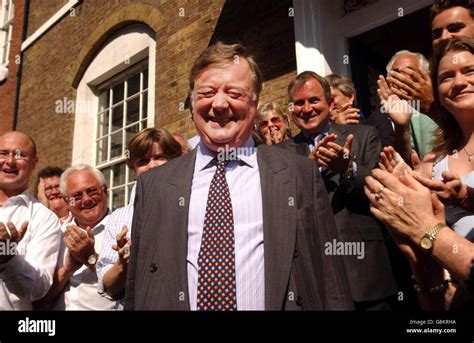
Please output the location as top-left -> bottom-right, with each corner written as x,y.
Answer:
279,71 -> 404,310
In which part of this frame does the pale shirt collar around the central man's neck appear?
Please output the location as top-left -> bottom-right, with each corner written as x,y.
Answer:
196,136 -> 257,171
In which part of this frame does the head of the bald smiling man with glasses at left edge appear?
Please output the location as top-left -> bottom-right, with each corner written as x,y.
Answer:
0,132 -> 38,196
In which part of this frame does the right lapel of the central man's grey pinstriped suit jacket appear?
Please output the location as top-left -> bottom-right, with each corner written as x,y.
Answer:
257,146 -> 297,310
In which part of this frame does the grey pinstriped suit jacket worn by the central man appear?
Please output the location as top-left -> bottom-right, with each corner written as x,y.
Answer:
125,145 -> 353,310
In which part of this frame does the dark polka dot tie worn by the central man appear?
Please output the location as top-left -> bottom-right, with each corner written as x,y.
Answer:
197,161 -> 237,311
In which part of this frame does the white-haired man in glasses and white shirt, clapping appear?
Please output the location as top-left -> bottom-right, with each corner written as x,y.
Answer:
37,164 -> 117,310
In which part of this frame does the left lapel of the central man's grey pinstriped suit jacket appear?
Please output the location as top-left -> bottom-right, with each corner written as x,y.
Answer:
158,149 -> 197,310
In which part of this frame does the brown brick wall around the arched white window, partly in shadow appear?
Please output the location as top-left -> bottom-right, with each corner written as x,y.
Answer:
18,0 -> 296,177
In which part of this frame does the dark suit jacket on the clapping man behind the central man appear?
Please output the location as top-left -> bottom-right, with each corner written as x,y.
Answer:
278,124 -> 397,302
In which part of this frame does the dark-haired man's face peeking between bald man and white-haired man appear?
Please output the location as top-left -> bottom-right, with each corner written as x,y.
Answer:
37,167 -> 69,223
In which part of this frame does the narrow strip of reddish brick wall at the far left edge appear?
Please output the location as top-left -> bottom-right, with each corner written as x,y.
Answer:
0,0 -> 24,135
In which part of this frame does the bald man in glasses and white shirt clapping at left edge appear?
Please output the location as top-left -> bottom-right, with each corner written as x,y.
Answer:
0,132 -> 61,310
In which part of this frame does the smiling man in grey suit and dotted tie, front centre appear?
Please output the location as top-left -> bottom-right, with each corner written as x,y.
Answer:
125,43 -> 353,310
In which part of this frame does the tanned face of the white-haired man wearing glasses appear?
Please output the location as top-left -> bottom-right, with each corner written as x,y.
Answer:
64,170 -> 107,228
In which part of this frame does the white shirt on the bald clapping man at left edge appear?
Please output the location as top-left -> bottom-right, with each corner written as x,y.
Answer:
0,192 -> 61,310
